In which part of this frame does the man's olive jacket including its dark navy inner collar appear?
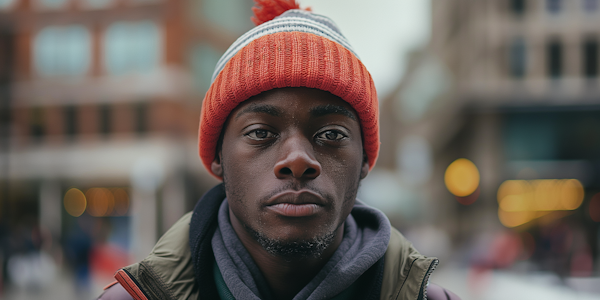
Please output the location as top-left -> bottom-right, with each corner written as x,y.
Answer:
115,184 -> 438,300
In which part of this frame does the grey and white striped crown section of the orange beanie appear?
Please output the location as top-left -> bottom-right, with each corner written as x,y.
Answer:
211,9 -> 360,84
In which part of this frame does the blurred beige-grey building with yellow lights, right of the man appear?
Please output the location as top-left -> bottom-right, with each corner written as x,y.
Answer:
378,0 -> 600,274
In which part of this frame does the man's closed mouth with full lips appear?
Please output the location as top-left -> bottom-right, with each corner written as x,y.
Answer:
266,190 -> 326,218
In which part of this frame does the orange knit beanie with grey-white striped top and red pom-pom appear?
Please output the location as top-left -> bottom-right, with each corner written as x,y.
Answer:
198,0 -> 379,179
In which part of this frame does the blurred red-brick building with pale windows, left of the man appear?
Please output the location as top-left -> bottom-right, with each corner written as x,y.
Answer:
0,0 -> 253,278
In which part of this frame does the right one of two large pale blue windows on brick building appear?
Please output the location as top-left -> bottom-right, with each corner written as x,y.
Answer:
104,21 -> 161,75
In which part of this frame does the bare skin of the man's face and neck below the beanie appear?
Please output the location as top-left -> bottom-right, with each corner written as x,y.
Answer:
211,88 -> 369,299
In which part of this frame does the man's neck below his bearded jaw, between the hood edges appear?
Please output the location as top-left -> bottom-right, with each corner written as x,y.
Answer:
229,211 -> 344,300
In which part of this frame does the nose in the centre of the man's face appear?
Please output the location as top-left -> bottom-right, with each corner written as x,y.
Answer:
274,137 -> 321,179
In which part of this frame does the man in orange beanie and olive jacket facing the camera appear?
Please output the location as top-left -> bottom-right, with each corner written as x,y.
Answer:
100,0 -> 457,299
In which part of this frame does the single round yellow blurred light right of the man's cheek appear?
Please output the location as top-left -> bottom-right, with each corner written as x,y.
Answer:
444,158 -> 479,197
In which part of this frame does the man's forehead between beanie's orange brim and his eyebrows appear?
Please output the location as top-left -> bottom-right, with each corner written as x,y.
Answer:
230,87 -> 358,121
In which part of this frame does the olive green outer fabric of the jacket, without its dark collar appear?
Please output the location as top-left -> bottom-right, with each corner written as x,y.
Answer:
111,212 -> 438,300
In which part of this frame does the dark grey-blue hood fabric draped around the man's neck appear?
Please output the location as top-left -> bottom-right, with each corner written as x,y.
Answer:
212,199 -> 391,300
